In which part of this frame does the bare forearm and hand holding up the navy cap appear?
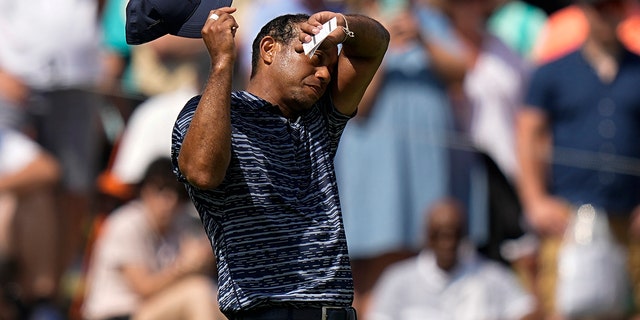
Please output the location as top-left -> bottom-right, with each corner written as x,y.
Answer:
178,8 -> 238,189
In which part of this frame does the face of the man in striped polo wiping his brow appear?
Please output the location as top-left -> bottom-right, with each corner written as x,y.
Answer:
273,31 -> 338,114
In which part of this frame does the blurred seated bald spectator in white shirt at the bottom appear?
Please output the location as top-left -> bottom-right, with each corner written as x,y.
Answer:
367,199 -> 535,320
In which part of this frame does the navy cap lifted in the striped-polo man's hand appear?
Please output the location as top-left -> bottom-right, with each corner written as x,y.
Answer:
125,0 -> 232,44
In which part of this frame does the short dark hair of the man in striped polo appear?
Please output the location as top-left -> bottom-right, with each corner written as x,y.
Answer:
251,13 -> 309,78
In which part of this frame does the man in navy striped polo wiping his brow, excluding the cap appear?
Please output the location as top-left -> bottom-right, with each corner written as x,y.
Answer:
171,7 -> 389,320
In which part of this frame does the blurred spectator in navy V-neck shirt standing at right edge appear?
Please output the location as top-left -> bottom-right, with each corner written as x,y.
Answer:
517,0 -> 640,314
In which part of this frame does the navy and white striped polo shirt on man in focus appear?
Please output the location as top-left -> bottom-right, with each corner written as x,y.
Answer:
171,92 -> 353,313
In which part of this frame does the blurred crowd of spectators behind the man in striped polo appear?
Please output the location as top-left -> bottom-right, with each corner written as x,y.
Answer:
0,0 -> 640,320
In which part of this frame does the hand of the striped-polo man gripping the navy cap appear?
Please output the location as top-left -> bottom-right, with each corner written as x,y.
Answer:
202,7 -> 238,66
